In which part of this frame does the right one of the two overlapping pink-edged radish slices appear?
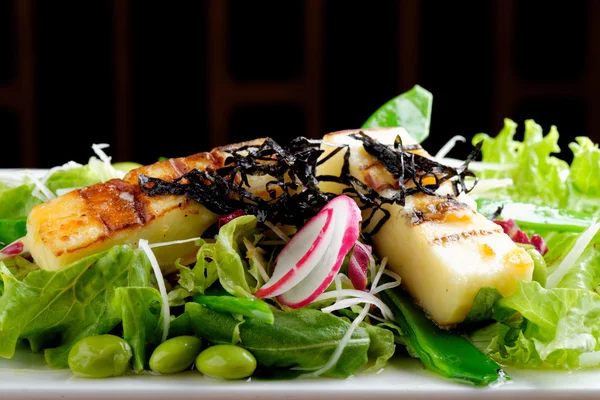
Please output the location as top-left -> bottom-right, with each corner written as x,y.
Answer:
277,195 -> 362,308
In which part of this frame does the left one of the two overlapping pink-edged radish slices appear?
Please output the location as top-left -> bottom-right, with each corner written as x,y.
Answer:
256,207 -> 335,299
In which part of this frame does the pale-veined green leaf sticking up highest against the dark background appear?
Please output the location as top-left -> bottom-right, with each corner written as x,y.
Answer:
362,85 -> 433,143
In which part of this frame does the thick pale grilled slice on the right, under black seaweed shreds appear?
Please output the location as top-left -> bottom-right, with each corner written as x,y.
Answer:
318,128 -> 533,326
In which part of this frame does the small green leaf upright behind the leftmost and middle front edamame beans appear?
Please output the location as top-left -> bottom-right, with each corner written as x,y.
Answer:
111,287 -> 163,371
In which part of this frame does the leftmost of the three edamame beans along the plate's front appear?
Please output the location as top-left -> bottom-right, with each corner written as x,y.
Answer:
68,335 -> 132,378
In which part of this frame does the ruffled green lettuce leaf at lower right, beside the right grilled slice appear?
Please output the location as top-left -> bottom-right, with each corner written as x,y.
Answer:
471,281 -> 600,369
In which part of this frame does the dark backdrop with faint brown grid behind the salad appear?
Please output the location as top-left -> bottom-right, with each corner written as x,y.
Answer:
0,0 -> 600,168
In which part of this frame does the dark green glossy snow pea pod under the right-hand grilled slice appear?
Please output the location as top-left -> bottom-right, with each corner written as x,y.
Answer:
381,289 -> 508,386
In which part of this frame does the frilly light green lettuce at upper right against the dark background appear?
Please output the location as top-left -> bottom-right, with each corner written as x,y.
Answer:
472,119 -> 600,216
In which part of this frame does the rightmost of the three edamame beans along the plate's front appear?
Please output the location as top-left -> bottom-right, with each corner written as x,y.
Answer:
196,344 -> 256,379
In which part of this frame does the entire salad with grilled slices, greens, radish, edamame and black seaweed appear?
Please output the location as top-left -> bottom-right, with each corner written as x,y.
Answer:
0,86 -> 600,386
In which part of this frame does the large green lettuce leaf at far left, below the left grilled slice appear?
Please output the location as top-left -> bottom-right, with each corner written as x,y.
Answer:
0,245 -> 151,368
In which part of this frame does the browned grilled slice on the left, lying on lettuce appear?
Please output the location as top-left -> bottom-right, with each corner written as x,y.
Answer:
24,139 -> 268,274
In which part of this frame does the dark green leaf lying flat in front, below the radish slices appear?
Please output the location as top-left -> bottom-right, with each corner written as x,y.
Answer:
185,303 -> 370,378
